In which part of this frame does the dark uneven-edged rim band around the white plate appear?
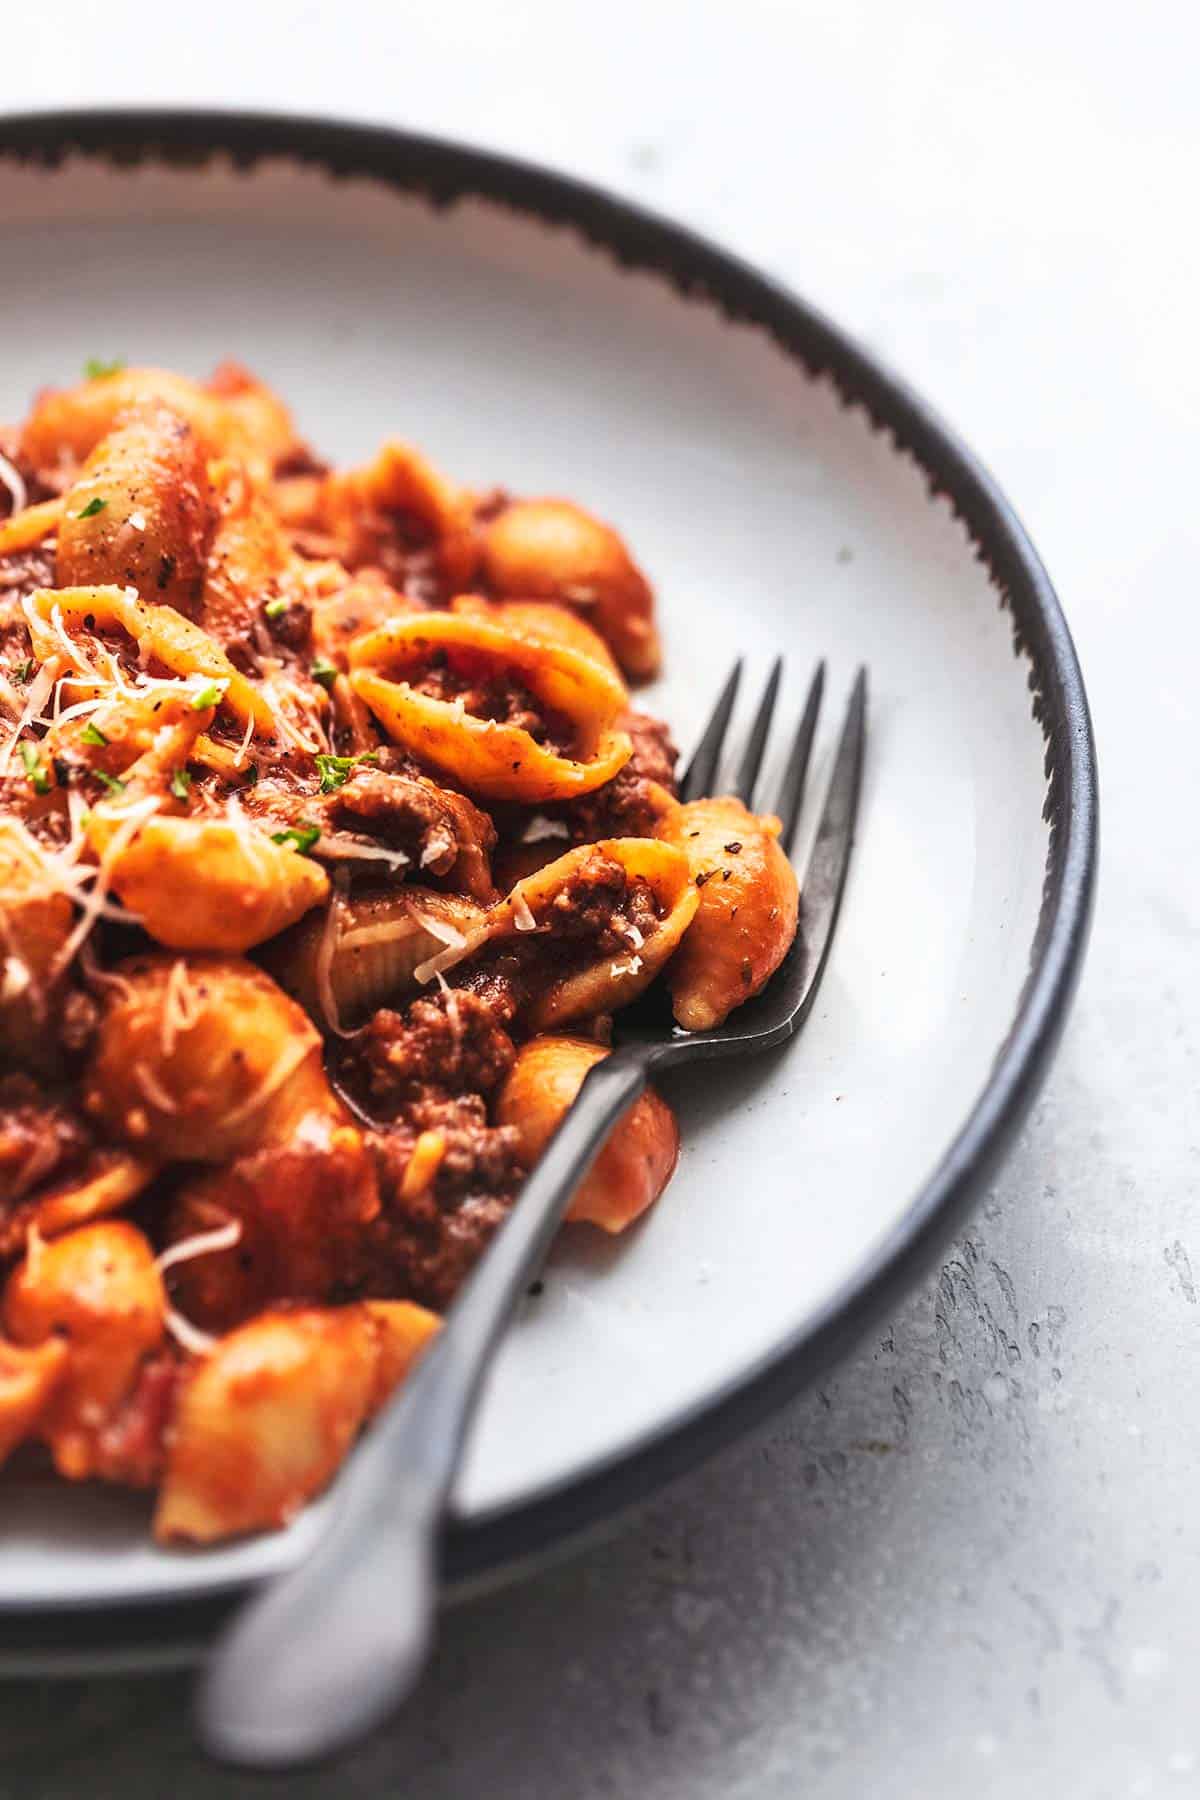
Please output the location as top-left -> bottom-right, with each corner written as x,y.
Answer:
0,110 -> 1099,1674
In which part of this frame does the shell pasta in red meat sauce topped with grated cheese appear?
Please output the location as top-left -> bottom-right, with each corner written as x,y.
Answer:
0,364 -> 797,1543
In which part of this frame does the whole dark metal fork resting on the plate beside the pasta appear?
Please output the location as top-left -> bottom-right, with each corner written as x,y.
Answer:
200,661 -> 867,1768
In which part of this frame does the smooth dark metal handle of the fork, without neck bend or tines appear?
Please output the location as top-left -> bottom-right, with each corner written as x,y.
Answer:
198,1044 -> 649,1768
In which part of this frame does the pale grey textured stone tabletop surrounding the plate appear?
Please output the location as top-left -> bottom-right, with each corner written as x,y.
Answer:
0,0 -> 1200,1800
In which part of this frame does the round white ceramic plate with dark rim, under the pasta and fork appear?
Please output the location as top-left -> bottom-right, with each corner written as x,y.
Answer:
0,115 -> 1096,1629
